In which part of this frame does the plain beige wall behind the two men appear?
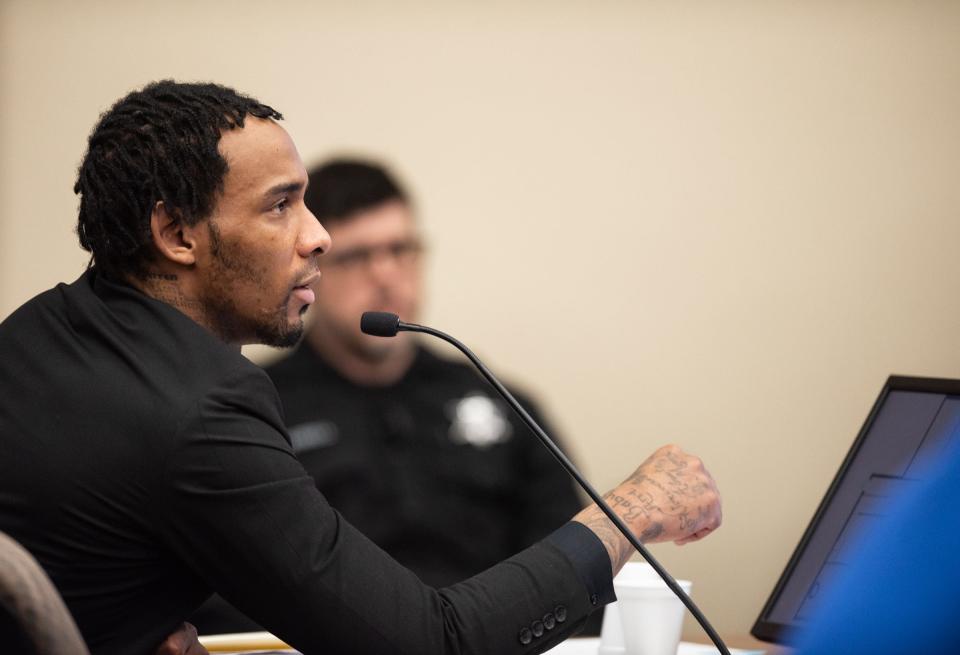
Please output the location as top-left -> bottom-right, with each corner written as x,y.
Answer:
0,0 -> 960,635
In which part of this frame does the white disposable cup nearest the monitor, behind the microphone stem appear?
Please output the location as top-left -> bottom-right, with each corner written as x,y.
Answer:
616,570 -> 692,655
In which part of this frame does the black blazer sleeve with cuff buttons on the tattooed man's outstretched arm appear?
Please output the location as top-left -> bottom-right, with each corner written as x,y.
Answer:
155,368 -> 610,655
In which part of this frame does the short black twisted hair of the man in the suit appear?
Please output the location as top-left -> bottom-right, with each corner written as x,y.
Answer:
73,80 -> 283,278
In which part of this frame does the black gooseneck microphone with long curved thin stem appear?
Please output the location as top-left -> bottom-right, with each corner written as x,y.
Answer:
360,312 -> 730,655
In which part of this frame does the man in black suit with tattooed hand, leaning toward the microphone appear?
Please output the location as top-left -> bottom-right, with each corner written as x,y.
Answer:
0,81 -> 720,655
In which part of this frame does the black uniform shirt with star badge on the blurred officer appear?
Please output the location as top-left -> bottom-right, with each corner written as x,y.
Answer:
267,342 -> 581,586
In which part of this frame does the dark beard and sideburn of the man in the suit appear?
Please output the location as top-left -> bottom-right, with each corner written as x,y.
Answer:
203,221 -> 306,348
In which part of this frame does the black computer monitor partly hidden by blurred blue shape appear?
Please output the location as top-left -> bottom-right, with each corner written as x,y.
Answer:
750,376 -> 960,643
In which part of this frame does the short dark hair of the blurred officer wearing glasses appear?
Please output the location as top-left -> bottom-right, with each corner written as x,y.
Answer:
303,158 -> 410,225
